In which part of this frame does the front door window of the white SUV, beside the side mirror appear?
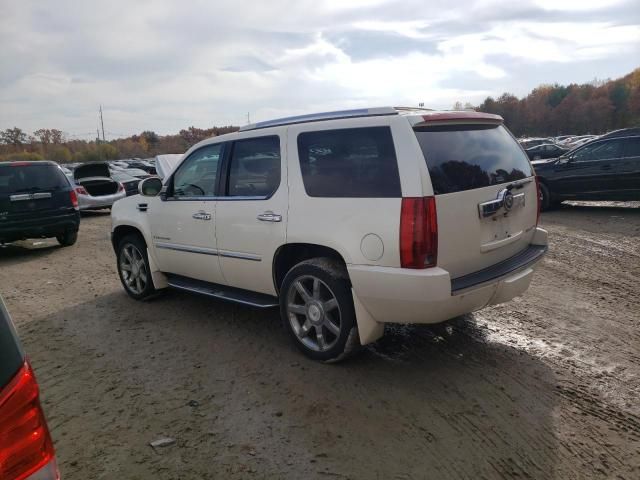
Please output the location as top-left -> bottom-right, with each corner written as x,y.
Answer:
173,143 -> 222,198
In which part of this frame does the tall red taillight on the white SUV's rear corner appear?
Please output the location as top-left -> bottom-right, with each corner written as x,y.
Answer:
400,197 -> 438,268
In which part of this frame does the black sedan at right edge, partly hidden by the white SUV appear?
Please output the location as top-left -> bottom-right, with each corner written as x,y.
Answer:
533,134 -> 640,210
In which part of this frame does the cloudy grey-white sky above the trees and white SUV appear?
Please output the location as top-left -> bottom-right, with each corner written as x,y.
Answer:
0,0 -> 640,139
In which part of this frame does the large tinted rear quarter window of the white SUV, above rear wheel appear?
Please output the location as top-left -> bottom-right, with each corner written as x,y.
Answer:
298,127 -> 402,198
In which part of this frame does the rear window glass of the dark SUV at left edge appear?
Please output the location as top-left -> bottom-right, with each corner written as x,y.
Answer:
0,164 -> 69,194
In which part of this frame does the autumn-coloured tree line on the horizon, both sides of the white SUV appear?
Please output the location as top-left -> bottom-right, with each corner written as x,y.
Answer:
0,68 -> 640,163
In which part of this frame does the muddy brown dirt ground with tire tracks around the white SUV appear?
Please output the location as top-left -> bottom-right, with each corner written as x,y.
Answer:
0,203 -> 640,480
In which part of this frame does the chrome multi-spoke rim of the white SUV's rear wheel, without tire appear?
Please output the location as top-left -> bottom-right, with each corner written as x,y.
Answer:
287,275 -> 342,352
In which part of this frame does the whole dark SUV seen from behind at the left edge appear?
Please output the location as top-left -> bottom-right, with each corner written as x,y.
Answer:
0,161 -> 80,246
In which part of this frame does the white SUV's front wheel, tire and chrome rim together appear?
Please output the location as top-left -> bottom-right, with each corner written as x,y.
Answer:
117,235 -> 156,300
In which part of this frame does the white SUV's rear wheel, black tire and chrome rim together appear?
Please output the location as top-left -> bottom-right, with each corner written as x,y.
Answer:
280,258 -> 360,363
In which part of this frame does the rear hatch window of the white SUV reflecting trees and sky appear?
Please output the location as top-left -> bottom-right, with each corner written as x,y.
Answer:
414,124 -> 533,195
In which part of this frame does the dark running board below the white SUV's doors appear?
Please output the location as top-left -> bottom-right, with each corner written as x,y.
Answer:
167,273 -> 279,308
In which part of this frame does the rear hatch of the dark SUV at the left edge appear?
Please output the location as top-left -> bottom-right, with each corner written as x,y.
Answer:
0,162 -> 74,224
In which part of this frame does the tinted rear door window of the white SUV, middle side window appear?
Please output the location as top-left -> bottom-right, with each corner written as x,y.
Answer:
227,135 -> 280,197
